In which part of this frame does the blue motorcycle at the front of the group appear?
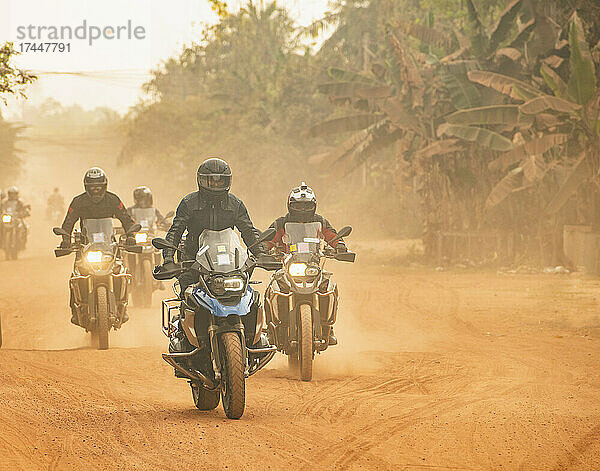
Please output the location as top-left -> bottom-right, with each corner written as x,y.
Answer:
152,228 -> 281,419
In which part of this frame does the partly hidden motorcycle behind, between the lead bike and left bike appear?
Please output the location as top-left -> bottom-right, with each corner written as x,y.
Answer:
126,208 -> 173,307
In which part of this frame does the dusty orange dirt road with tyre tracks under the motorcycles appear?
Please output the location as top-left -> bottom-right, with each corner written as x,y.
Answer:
0,245 -> 600,471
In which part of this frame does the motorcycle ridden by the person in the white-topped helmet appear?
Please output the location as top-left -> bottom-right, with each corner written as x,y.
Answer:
265,222 -> 356,381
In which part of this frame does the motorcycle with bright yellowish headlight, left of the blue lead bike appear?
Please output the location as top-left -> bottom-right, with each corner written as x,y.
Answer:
53,218 -> 142,350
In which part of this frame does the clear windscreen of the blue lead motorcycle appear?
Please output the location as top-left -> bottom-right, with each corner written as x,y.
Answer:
196,228 -> 248,273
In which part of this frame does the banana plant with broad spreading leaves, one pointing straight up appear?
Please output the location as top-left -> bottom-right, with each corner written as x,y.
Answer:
446,13 -> 600,218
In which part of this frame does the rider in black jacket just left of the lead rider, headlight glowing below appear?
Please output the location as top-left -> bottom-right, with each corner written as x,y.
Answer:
60,167 -> 135,324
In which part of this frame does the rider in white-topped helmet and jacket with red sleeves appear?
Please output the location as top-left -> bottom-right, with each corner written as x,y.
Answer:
266,182 -> 348,345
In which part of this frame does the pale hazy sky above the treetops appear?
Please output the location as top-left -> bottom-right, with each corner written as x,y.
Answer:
0,0 -> 327,115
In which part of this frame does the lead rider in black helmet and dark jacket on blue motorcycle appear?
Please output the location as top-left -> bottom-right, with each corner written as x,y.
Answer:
157,158 -> 265,352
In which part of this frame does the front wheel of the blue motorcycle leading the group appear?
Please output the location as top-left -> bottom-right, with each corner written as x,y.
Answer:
219,332 -> 246,419
